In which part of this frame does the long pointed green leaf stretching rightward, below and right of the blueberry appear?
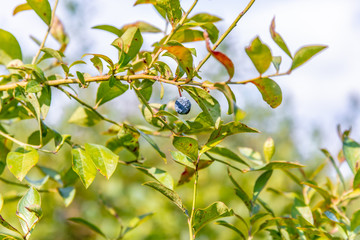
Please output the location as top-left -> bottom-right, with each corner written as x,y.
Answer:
200,122 -> 259,153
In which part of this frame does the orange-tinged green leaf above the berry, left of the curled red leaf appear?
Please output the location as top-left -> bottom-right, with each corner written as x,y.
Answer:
162,41 -> 194,79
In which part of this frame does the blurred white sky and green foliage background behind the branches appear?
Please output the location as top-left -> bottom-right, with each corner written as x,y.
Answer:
0,0 -> 360,240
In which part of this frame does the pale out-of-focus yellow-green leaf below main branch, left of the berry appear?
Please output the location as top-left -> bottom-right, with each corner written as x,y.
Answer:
68,106 -> 102,127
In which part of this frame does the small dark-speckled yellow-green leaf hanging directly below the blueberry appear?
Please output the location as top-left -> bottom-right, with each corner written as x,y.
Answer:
173,136 -> 199,161
